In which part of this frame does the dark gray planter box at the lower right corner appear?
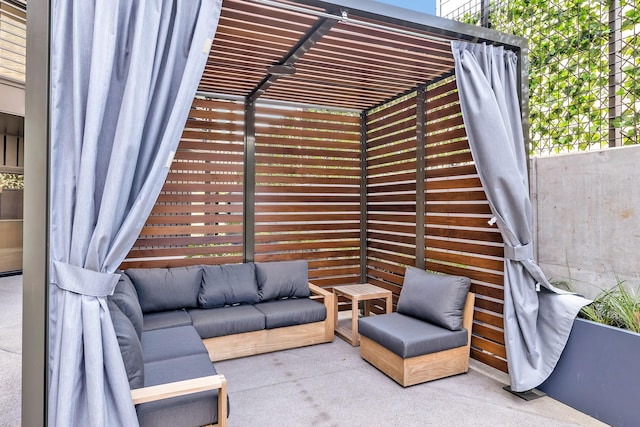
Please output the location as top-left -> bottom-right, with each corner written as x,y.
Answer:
538,319 -> 640,426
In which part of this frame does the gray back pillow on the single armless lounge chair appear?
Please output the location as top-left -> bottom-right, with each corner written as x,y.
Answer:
398,267 -> 471,331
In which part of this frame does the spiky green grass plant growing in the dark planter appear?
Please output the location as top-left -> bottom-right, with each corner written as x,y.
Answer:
580,279 -> 640,333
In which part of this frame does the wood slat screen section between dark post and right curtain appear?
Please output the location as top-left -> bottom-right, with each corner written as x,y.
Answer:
425,78 -> 507,371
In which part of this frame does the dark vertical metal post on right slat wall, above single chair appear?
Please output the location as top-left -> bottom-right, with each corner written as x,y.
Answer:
416,86 -> 427,270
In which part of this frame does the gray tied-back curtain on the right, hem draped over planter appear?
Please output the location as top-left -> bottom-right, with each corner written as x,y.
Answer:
451,42 -> 589,392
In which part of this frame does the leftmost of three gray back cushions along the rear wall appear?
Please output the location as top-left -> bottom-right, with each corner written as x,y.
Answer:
125,266 -> 202,313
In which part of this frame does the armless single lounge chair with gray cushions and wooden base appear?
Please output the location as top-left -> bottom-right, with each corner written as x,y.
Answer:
358,267 -> 475,387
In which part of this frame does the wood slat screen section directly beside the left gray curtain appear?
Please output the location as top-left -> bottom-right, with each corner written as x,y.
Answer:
122,99 -> 244,268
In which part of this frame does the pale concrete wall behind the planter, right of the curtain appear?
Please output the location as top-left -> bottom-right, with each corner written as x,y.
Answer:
531,146 -> 640,297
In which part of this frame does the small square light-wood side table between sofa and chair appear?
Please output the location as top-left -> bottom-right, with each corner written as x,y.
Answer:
333,283 -> 392,347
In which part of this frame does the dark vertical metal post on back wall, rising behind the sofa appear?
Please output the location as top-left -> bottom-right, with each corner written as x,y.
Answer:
242,99 -> 256,262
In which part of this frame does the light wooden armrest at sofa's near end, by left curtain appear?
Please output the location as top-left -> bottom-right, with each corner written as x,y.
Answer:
131,375 -> 227,426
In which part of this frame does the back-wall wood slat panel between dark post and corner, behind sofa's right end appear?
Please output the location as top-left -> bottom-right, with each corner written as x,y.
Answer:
255,104 -> 360,287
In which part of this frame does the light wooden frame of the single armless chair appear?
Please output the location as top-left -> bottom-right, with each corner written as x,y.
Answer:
360,292 -> 475,387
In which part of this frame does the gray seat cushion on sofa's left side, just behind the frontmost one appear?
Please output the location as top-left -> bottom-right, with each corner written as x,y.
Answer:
142,326 -> 208,363
